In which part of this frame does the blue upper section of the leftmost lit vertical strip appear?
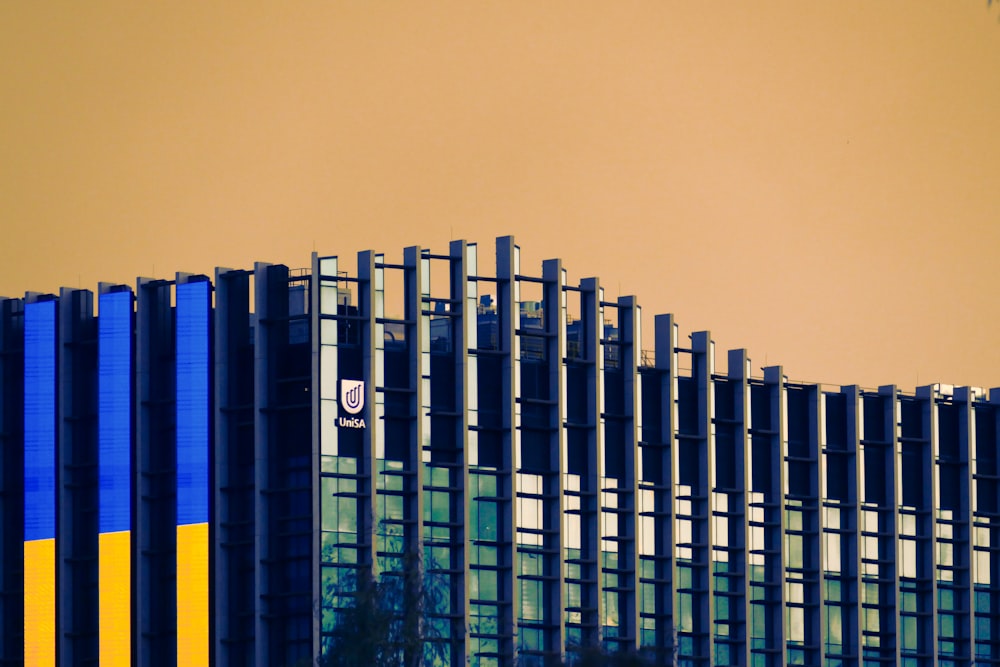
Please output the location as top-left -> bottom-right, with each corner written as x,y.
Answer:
24,301 -> 58,542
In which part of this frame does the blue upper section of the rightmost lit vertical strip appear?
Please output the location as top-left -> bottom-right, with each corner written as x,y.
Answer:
176,281 -> 212,526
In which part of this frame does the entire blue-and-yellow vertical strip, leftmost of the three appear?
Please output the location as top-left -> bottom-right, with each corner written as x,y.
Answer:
24,301 -> 58,667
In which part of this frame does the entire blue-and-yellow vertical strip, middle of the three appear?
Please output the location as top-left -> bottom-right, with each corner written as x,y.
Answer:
97,290 -> 133,667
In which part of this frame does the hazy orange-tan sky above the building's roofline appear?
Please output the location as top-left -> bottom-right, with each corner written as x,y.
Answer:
0,0 -> 1000,390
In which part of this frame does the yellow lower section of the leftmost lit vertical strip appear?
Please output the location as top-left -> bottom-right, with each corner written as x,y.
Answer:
24,539 -> 56,667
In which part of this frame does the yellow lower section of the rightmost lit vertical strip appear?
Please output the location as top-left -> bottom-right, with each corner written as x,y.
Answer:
177,523 -> 208,665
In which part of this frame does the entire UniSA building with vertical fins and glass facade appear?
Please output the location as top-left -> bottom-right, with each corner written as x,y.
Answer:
0,237 -> 1000,667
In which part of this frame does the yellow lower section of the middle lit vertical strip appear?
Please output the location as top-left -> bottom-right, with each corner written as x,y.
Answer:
97,530 -> 132,667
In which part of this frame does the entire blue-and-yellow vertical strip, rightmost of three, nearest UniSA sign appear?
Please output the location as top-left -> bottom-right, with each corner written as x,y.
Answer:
176,281 -> 212,665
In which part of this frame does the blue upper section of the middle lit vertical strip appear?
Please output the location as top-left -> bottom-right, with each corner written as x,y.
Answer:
97,291 -> 132,533
